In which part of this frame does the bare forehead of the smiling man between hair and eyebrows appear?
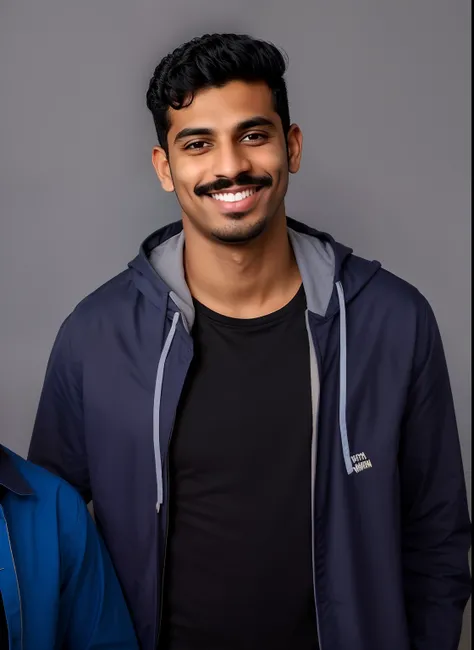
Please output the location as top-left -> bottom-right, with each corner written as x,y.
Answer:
168,81 -> 278,140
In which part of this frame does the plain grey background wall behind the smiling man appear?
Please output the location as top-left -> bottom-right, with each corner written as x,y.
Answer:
0,0 -> 471,648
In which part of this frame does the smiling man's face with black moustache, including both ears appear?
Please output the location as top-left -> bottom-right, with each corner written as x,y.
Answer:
153,81 -> 302,244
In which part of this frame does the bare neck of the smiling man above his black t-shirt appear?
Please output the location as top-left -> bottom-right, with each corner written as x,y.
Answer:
183,215 -> 301,318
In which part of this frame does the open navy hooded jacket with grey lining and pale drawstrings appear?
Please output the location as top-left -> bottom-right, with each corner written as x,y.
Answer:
30,219 -> 470,650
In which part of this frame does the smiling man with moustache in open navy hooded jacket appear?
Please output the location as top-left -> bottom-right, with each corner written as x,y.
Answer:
30,34 -> 469,650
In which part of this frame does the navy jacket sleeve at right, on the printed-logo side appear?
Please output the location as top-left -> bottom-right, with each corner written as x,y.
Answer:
399,299 -> 471,650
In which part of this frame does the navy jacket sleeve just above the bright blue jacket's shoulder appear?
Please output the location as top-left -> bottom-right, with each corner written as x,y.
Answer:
28,316 -> 91,502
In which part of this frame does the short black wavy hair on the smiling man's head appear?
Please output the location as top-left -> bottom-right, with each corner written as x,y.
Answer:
146,34 -> 290,151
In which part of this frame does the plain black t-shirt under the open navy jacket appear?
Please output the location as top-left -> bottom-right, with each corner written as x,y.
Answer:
161,288 -> 318,650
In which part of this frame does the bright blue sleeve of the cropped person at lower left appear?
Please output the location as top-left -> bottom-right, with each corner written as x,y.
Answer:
57,483 -> 138,650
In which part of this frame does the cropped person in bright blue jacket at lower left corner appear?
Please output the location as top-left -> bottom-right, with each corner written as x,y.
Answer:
0,445 -> 138,650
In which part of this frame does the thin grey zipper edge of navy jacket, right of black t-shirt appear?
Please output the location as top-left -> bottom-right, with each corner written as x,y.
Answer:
306,310 -> 323,650
